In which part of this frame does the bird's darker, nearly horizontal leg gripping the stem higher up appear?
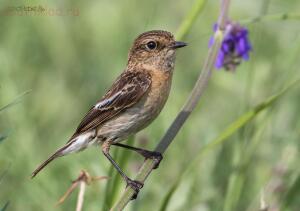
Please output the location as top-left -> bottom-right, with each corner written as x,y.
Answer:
112,143 -> 163,169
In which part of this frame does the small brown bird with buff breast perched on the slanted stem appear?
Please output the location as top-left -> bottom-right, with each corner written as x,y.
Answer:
32,30 -> 186,194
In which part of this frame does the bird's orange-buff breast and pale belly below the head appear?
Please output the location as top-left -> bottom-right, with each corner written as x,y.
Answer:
98,72 -> 172,141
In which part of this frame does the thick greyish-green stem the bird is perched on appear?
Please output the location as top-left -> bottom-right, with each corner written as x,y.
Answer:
111,0 -> 230,211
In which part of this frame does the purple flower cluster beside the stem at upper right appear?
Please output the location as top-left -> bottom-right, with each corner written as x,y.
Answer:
209,22 -> 252,71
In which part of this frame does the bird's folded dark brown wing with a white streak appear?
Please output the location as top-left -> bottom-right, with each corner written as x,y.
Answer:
70,71 -> 151,141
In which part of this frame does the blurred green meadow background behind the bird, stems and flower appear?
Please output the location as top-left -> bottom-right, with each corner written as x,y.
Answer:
0,0 -> 300,211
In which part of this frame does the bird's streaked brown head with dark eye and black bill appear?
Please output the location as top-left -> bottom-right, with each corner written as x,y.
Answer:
128,30 -> 187,71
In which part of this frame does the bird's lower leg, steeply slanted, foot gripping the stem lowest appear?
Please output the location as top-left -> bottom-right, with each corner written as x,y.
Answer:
102,141 -> 144,199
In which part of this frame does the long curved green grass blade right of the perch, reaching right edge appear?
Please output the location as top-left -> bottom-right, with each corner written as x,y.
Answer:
159,79 -> 300,211
